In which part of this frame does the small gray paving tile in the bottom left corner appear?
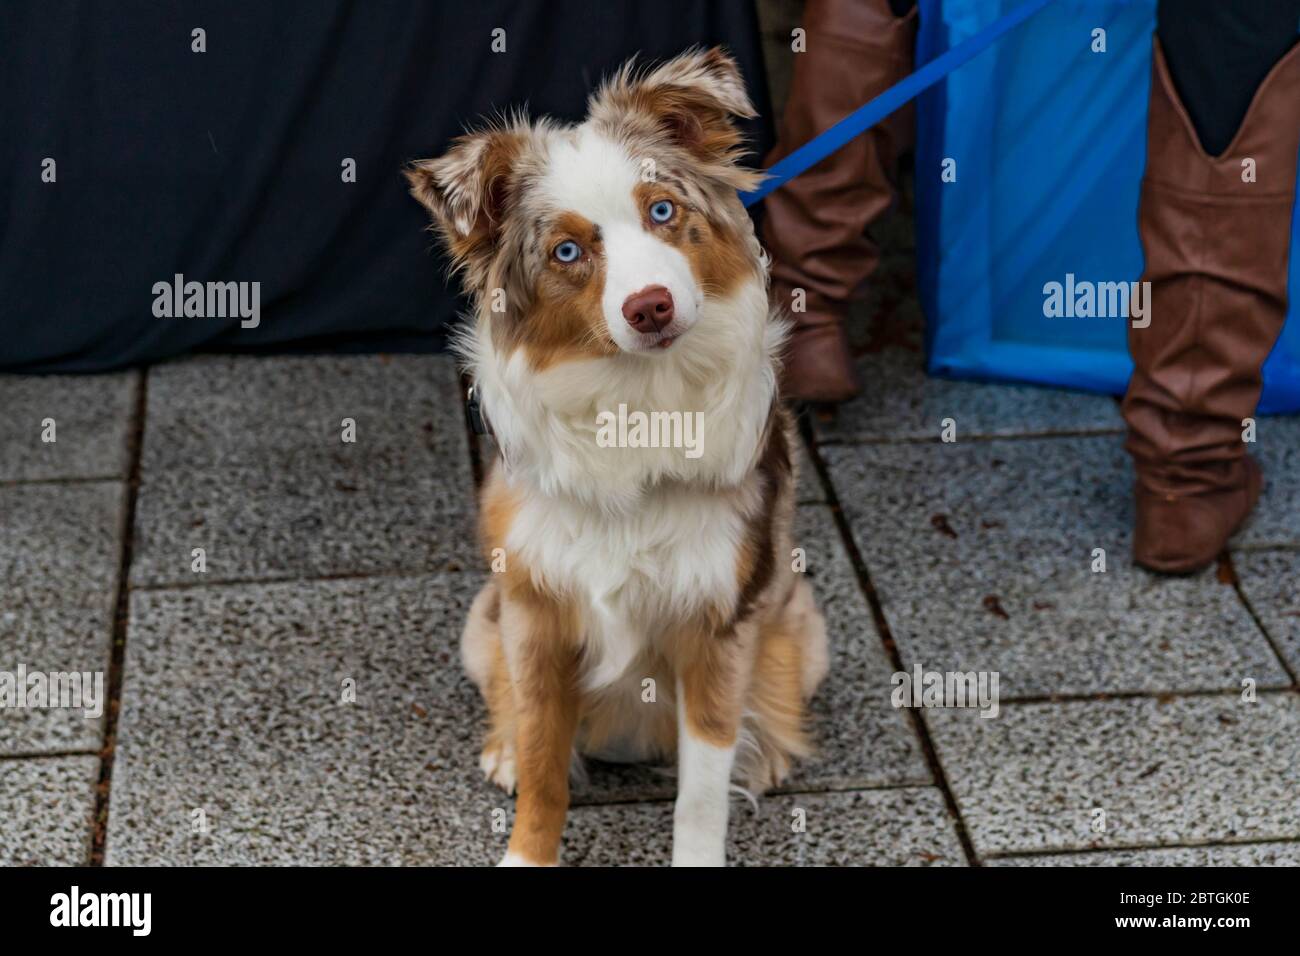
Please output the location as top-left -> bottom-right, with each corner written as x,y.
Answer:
0,757 -> 99,866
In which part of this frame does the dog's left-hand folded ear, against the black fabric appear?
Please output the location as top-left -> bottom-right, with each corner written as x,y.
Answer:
404,129 -> 525,287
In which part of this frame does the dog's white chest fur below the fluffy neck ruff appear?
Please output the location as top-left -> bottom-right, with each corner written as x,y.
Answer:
507,485 -> 745,688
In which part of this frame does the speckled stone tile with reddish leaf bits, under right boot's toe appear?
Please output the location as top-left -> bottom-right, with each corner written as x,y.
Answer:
822,436 -> 1290,698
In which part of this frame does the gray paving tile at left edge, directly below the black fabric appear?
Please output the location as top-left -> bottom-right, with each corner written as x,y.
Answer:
0,372 -> 139,481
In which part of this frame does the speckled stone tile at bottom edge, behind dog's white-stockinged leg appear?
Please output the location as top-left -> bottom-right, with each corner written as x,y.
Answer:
559,787 -> 966,866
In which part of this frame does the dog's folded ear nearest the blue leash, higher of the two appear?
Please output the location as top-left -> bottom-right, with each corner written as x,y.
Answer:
589,47 -> 761,190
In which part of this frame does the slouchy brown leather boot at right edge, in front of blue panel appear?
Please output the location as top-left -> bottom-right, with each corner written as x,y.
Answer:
1123,39 -> 1300,574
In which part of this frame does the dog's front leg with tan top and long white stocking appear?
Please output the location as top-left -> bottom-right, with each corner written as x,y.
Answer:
672,633 -> 753,866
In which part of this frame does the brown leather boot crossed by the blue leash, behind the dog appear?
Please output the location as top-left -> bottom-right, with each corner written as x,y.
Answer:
763,0 -> 917,402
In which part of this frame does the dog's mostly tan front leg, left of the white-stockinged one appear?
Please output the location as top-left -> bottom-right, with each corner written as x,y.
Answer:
502,596 -> 579,866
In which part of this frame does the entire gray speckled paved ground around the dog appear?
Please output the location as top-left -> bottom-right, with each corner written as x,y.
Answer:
0,345 -> 1300,865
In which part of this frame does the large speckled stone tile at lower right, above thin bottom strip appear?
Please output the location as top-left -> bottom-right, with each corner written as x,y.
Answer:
923,693 -> 1300,856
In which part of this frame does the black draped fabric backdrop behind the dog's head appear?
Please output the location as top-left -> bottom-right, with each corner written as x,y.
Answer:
0,0 -> 771,372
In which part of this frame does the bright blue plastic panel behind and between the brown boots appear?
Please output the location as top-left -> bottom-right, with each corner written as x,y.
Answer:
917,0 -> 1300,414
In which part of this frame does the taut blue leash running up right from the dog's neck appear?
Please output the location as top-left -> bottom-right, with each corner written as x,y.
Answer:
740,0 -> 1052,206
